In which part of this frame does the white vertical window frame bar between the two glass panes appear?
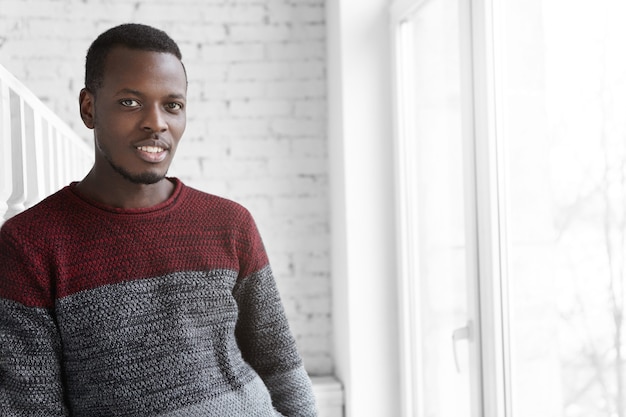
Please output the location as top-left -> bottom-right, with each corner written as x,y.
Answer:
471,0 -> 512,417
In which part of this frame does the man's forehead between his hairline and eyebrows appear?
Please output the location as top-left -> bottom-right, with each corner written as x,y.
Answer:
101,46 -> 187,94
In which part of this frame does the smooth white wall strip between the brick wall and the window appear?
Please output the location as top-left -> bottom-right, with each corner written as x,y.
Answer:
327,0 -> 400,417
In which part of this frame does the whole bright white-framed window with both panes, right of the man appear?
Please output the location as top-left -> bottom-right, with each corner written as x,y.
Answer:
392,0 -> 626,417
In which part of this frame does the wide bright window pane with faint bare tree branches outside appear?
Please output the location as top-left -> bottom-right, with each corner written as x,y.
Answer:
496,0 -> 626,417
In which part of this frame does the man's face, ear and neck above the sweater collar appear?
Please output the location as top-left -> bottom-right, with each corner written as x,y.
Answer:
76,46 -> 187,208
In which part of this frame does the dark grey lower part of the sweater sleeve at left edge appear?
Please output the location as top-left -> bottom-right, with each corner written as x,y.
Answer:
0,299 -> 67,417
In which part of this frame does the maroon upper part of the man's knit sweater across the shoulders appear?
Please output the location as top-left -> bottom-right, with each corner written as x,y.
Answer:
0,180 -> 267,307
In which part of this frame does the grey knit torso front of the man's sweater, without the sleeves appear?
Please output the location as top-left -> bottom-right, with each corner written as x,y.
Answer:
57,270 -> 283,417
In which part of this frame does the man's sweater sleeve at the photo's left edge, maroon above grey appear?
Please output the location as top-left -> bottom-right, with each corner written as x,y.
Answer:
0,226 -> 68,417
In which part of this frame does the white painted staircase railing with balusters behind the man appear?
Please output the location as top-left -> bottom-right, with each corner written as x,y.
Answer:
0,65 -> 93,224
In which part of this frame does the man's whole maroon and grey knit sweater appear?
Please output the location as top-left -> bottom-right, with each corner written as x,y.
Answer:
0,179 -> 315,417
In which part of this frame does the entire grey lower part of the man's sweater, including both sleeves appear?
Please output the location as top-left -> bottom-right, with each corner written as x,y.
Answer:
0,266 -> 316,417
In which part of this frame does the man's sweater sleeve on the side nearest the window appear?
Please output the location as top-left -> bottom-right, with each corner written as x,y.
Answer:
233,213 -> 316,417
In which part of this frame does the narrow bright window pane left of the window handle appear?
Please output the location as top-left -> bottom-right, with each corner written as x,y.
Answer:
399,0 -> 470,417
